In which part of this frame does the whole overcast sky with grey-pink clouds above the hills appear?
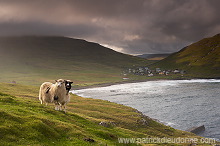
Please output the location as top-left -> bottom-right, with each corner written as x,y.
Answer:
0,0 -> 220,54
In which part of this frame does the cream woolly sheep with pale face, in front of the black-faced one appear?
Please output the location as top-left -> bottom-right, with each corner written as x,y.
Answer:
39,79 -> 67,111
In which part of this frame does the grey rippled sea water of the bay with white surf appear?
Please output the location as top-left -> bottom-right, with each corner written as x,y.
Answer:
72,79 -> 220,140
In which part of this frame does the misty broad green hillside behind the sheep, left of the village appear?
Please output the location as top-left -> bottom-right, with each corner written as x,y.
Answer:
0,36 -> 148,85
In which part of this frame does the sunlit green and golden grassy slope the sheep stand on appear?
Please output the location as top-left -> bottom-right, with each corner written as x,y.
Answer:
0,83 -> 208,145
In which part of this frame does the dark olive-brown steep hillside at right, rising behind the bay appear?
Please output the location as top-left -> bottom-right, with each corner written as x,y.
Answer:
152,34 -> 220,78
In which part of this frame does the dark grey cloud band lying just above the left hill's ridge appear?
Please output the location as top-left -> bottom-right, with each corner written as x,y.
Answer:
0,22 -> 101,38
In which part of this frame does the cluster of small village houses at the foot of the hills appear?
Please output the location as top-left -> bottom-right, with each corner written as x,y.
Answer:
123,67 -> 186,77
